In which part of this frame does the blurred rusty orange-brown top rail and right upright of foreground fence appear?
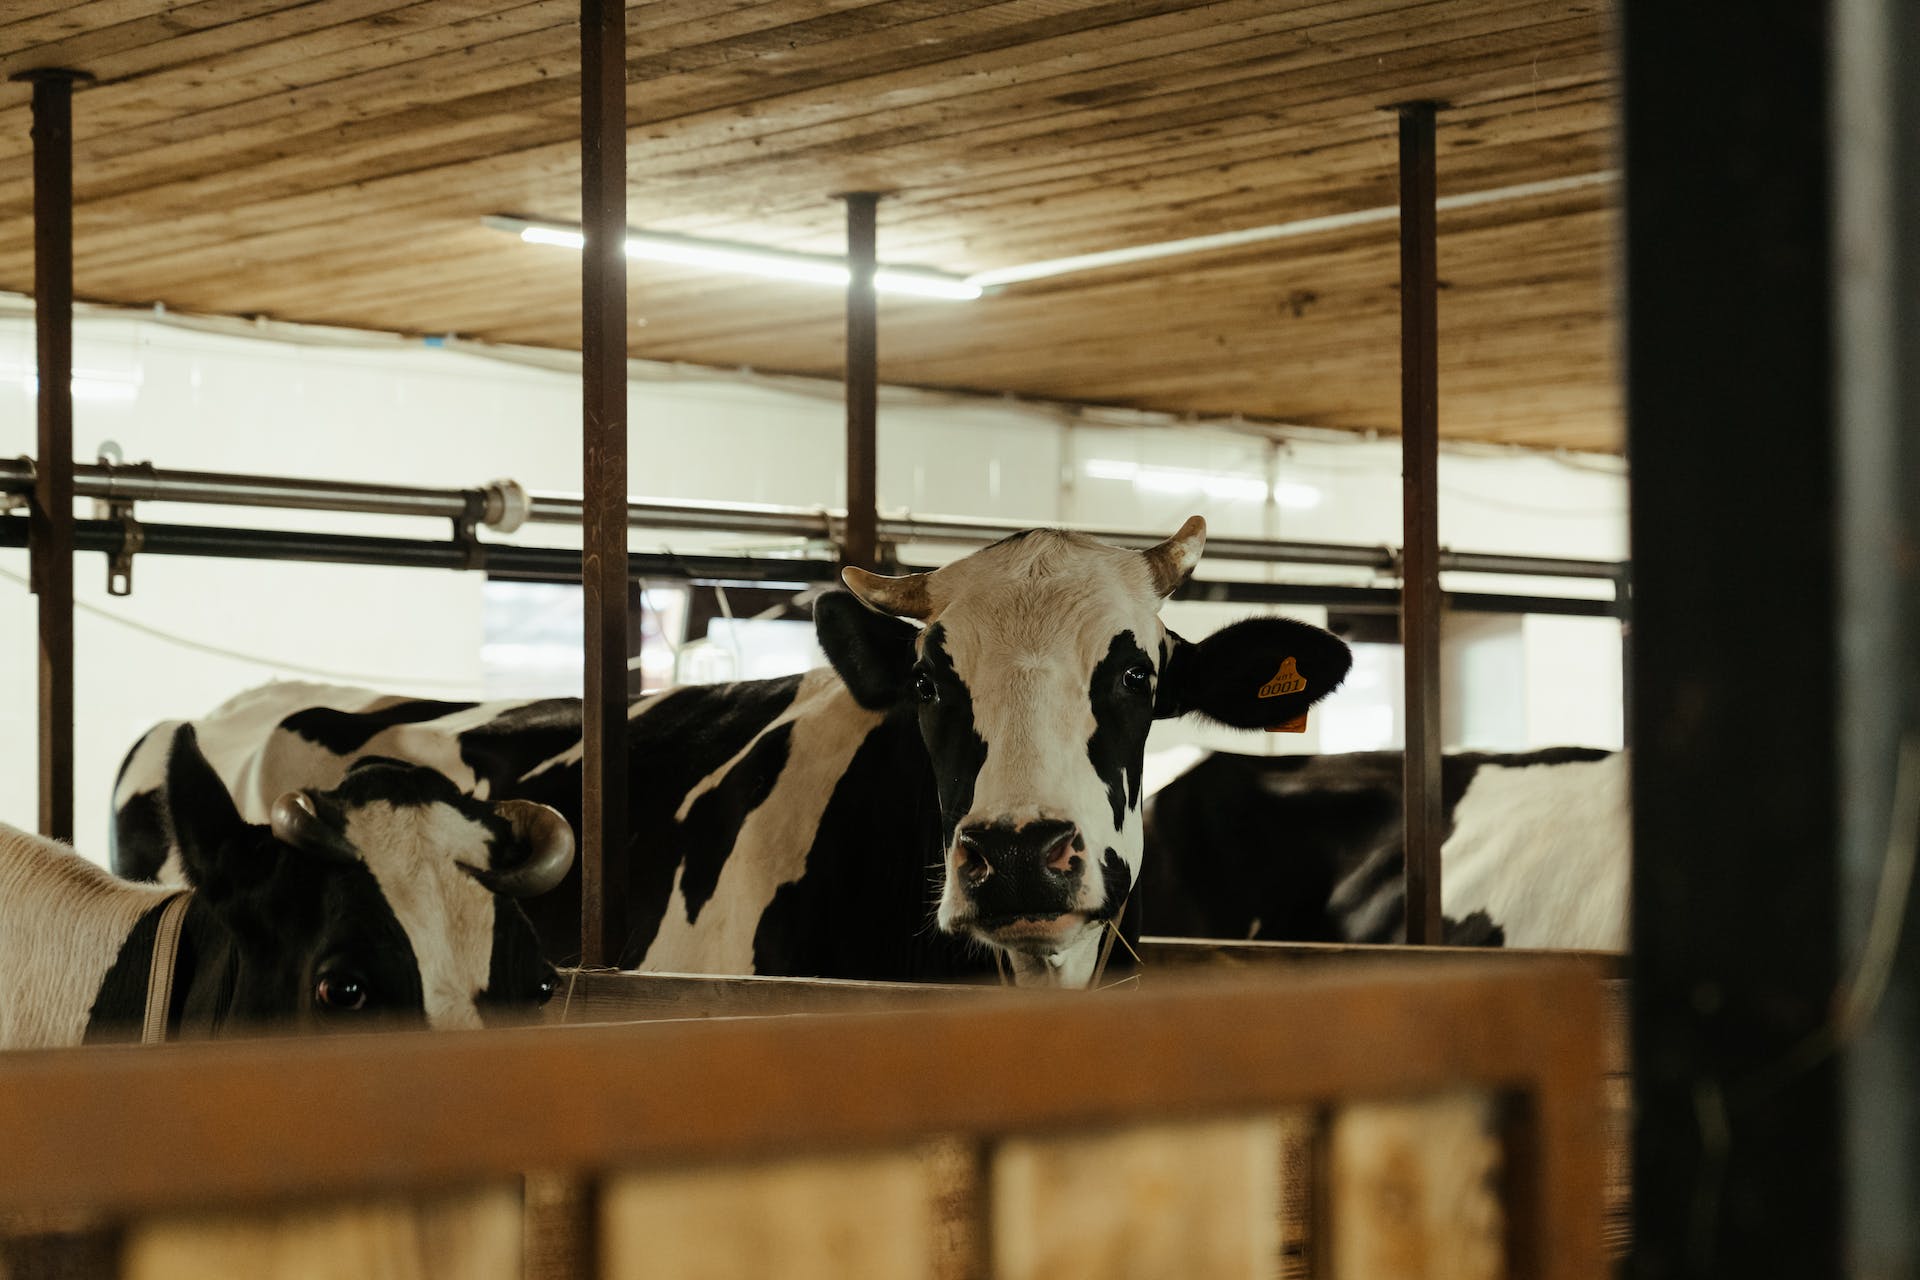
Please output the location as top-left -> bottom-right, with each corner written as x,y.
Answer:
0,961 -> 1603,1280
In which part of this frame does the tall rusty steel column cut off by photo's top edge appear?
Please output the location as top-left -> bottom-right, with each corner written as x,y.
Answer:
580,0 -> 628,965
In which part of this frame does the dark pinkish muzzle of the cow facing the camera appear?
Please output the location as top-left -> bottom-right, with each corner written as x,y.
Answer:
950,818 -> 1087,954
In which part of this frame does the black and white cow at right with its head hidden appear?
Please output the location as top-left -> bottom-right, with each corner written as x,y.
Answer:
1140,747 -> 1630,950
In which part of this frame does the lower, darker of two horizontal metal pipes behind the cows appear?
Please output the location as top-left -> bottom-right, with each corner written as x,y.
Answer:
0,516 -> 1617,618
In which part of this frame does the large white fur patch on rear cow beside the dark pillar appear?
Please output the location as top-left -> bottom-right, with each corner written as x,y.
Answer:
1440,752 -> 1632,950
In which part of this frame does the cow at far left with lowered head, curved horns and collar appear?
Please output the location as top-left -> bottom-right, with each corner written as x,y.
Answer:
0,725 -> 574,1048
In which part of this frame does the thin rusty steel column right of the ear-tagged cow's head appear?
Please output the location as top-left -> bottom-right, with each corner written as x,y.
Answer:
1400,102 -> 1444,944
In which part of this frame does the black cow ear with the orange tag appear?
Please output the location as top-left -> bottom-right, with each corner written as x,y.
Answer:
1154,618 -> 1354,729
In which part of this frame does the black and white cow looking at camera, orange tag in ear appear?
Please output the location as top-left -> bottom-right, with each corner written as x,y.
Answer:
115,518 -> 1350,984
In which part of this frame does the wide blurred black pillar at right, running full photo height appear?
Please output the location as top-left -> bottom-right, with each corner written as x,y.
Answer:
1622,0 -> 1841,1276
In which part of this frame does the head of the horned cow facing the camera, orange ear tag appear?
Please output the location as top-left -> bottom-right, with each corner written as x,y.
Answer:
816,516 -> 1352,984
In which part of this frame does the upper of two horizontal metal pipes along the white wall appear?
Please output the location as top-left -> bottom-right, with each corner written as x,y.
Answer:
0,459 -> 1622,580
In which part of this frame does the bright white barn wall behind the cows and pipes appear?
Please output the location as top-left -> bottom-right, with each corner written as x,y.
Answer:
0,315 -> 1624,858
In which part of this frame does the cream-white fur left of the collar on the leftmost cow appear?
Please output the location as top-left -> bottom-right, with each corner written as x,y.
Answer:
0,823 -> 173,1050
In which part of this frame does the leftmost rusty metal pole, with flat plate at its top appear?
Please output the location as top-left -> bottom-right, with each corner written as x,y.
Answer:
13,69 -> 92,841
